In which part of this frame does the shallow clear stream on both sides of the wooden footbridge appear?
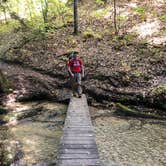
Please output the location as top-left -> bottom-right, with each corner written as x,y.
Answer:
0,101 -> 166,166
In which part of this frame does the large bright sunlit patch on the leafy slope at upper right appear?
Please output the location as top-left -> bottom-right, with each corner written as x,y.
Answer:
130,20 -> 160,38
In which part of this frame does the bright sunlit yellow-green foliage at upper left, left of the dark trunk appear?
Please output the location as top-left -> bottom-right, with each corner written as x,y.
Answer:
1,0 -> 72,30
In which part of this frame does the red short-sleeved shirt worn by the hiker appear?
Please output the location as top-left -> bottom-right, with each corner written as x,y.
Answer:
68,59 -> 83,72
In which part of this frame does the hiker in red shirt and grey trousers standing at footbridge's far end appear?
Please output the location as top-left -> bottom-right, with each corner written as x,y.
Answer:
68,51 -> 84,97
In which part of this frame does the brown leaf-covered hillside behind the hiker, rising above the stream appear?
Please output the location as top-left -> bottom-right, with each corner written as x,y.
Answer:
0,1 -> 166,118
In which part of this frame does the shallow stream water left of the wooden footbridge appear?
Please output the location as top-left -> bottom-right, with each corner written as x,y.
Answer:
1,102 -> 66,166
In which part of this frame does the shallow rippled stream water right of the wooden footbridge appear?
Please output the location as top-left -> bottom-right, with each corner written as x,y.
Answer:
93,107 -> 166,166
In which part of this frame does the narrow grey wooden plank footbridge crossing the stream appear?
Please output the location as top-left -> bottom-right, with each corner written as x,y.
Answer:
58,95 -> 117,166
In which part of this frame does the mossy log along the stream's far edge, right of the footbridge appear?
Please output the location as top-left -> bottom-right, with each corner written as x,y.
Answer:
116,103 -> 166,119
